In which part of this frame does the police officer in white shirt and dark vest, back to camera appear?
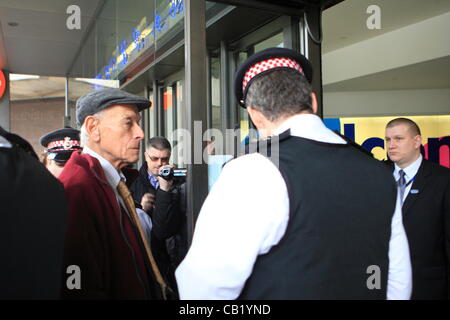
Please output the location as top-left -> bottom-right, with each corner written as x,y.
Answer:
176,48 -> 411,299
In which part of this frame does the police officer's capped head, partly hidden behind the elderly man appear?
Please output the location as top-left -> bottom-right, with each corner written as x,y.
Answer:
40,128 -> 82,178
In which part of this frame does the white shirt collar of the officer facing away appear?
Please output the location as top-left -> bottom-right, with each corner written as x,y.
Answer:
273,114 -> 347,144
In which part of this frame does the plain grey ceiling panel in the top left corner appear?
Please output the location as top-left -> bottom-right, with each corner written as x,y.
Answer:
0,0 -> 103,76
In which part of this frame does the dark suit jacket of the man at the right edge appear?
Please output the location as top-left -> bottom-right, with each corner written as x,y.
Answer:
390,159 -> 450,299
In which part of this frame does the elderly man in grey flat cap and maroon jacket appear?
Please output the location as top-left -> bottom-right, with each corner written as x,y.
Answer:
59,89 -> 168,299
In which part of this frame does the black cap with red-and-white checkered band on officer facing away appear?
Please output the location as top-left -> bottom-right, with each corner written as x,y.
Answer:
234,48 -> 313,108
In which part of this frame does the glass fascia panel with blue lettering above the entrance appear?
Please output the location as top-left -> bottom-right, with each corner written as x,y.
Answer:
70,0 -> 184,81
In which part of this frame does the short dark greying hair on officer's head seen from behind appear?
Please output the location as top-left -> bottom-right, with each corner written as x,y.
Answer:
245,69 -> 313,121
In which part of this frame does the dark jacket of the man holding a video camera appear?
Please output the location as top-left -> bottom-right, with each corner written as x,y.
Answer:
130,162 -> 187,289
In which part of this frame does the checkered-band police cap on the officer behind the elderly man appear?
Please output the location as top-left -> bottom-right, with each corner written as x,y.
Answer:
40,128 -> 82,162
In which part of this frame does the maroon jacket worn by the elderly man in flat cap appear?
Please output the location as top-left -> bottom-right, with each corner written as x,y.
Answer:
59,152 -> 155,299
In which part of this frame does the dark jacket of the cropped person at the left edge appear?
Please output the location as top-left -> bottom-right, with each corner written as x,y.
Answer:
0,128 -> 67,300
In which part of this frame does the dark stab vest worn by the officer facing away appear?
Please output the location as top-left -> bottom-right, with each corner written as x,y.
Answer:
239,131 -> 396,299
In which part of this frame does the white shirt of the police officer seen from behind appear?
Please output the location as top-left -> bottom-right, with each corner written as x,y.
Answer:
176,114 -> 412,299
